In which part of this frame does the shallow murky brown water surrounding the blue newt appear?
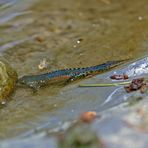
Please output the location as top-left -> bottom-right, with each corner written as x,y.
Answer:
0,0 -> 148,138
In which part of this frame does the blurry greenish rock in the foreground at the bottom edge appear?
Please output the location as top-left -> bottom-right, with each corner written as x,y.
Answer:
59,122 -> 103,148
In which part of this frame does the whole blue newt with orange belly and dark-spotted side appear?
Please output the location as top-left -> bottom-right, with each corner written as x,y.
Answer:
18,60 -> 126,90
